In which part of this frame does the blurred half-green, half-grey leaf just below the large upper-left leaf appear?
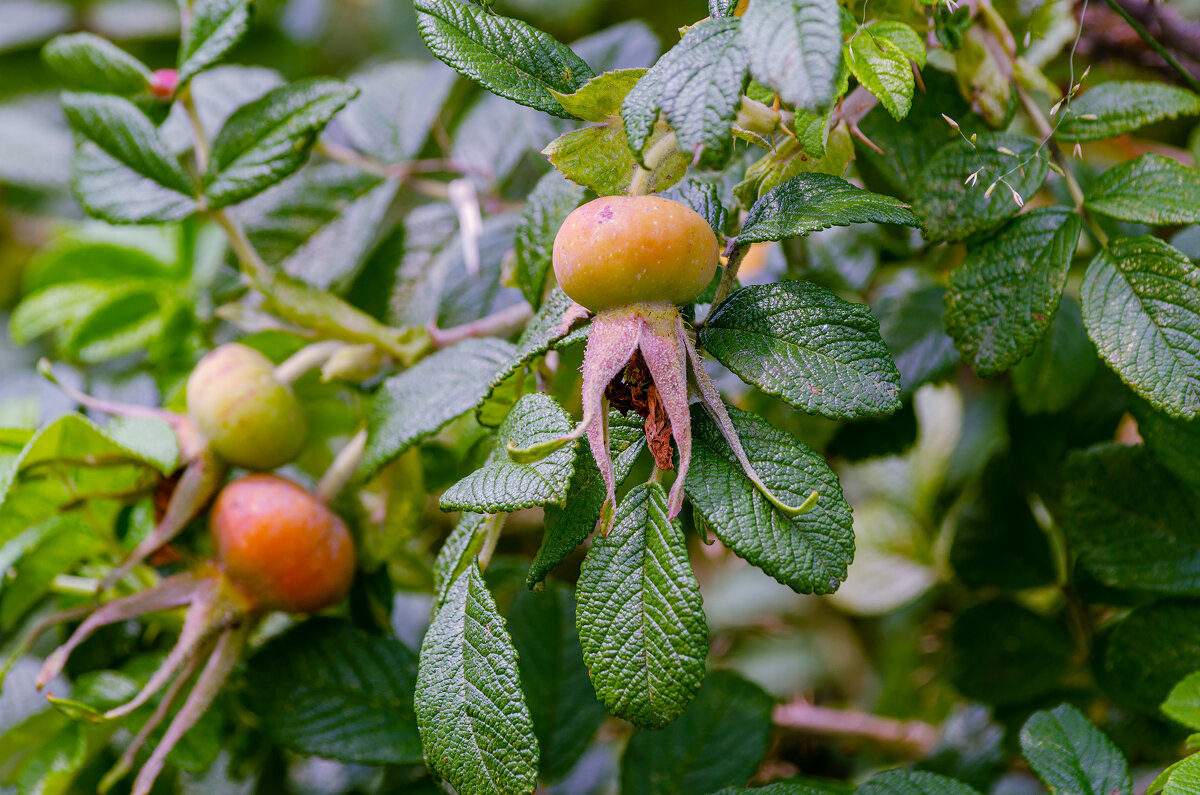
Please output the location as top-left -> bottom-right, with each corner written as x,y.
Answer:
238,163 -> 398,292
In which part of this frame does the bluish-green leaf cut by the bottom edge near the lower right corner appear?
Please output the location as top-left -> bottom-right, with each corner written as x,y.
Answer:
1021,704 -> 1133,795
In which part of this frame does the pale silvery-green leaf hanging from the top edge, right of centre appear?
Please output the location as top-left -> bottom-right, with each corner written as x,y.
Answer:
742,0 -> 841,110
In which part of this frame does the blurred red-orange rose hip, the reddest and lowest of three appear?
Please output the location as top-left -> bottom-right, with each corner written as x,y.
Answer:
210,474 -> 355,612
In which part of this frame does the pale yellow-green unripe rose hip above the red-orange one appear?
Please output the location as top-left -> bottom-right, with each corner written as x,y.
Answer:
187,342 -> 307,470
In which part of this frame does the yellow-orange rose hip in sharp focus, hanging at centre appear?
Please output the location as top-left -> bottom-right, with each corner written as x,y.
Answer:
553,196 -> 720,312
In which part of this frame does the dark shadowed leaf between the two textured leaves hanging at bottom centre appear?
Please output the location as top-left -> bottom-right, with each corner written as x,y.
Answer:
509,585 -> 605,782
